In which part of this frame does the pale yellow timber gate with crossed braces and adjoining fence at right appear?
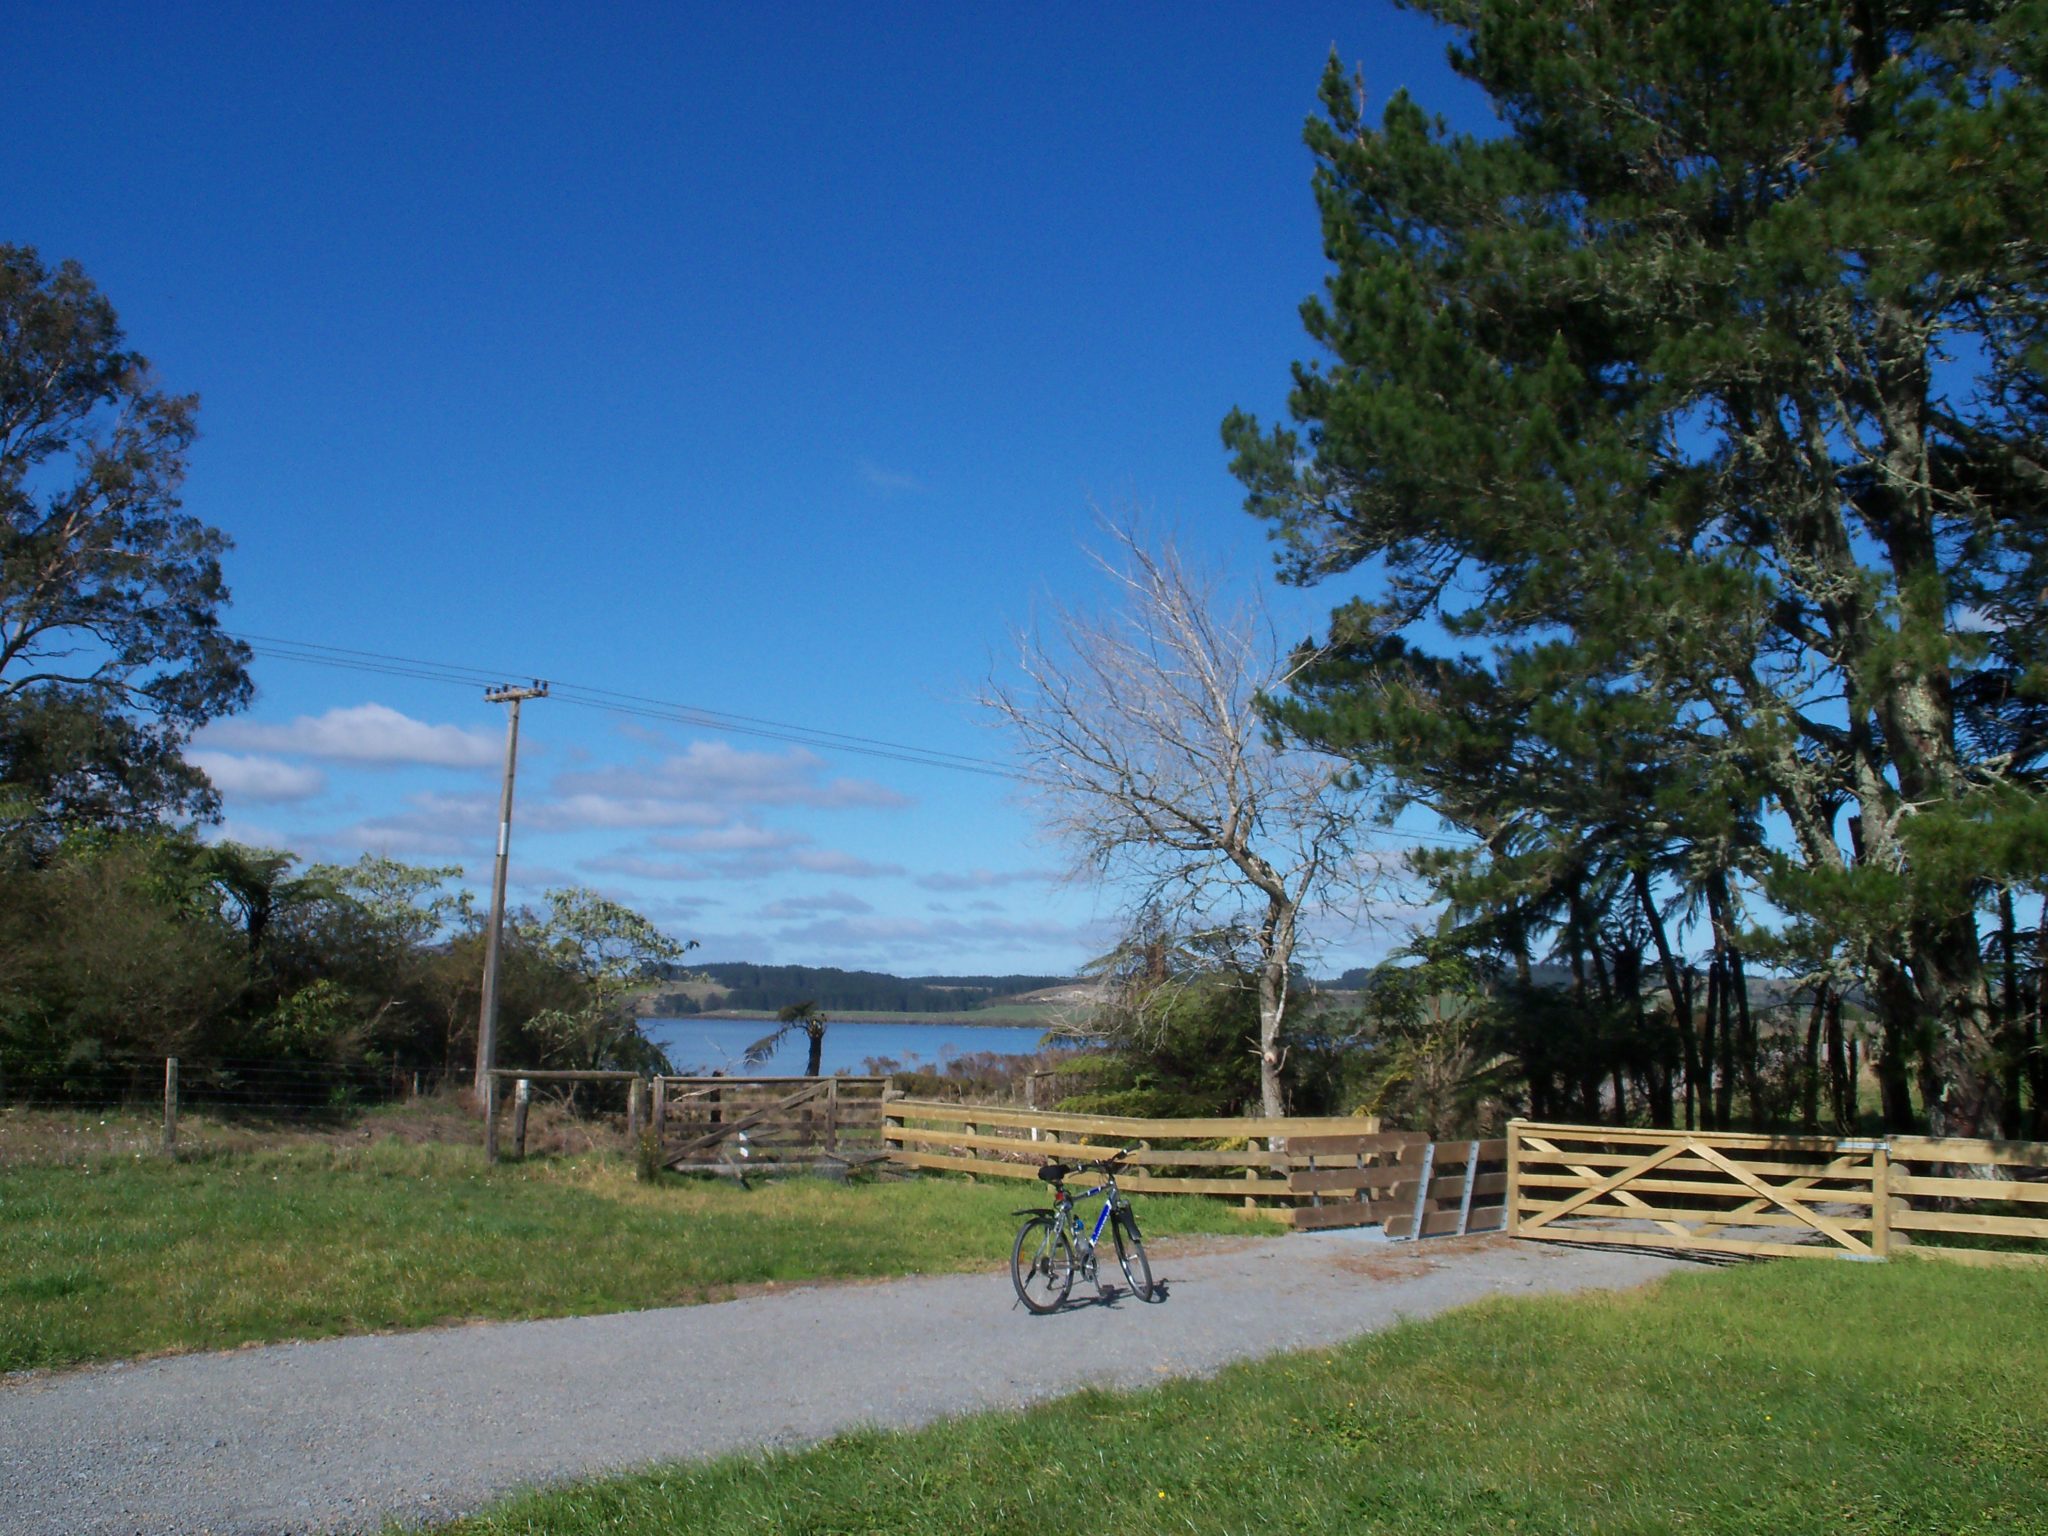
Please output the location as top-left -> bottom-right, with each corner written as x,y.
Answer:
1505,1120 -> 2048,1264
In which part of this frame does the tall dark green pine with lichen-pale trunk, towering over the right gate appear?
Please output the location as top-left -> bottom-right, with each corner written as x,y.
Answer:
1225,0 -> 2048,1133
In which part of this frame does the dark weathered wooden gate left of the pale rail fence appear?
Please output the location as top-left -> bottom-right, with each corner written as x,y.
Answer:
651,1077 -> 889,1174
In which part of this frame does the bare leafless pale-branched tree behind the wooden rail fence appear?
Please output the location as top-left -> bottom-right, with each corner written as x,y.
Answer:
981,520 -> 1376,1114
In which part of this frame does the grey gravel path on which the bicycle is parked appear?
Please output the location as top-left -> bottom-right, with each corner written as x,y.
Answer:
0,1233 -> 1679,1536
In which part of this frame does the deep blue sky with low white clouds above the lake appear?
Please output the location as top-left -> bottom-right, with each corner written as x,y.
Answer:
12,4 -> 1487,973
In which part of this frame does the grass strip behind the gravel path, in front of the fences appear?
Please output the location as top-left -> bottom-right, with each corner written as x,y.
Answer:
0,1141 -> 1247,1370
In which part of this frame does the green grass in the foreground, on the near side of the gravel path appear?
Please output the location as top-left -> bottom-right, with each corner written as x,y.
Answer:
432,1264 -> 2048,1536
